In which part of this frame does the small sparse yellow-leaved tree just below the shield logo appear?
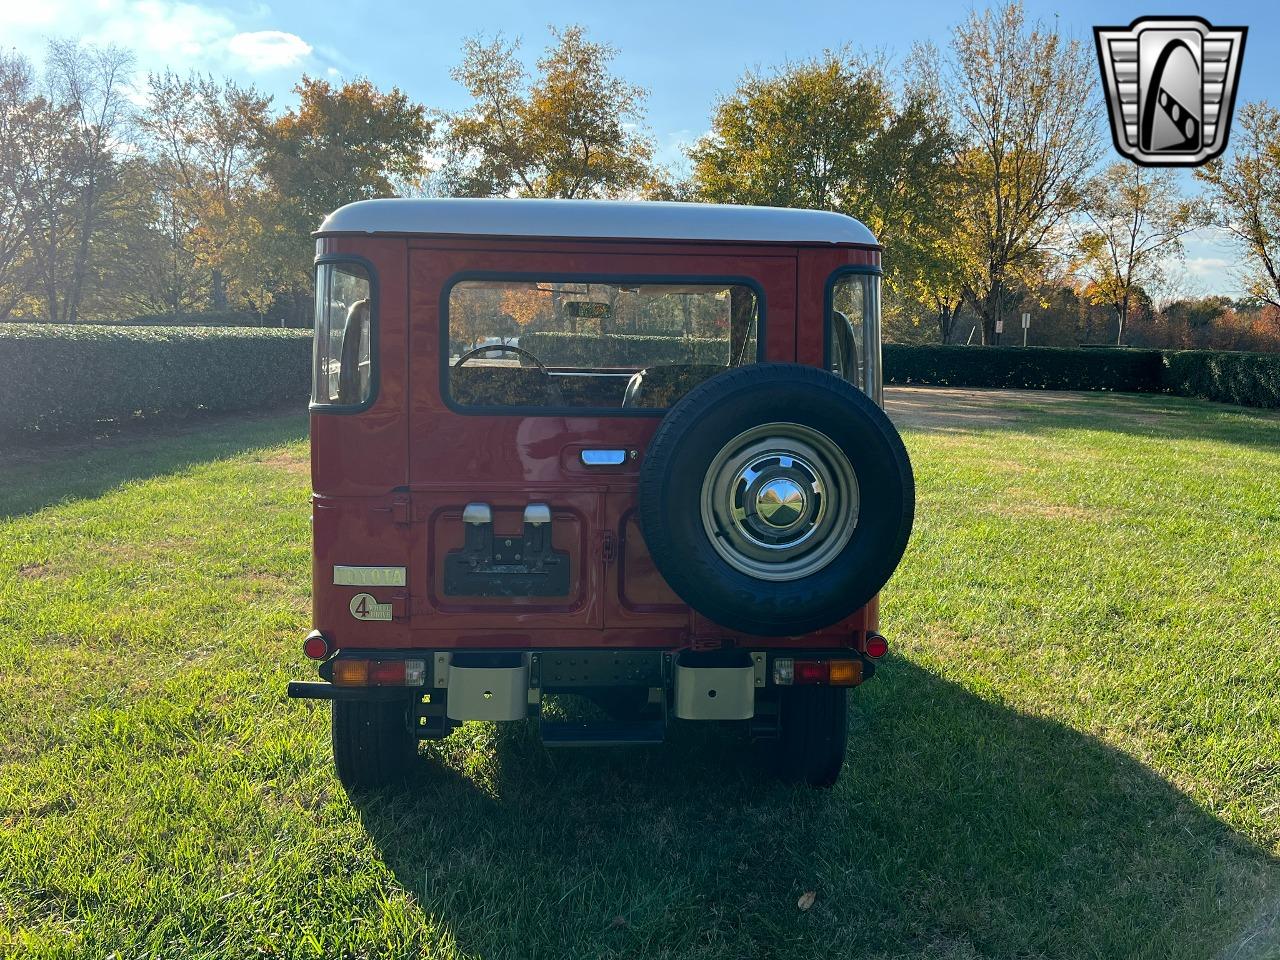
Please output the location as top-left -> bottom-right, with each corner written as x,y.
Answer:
1076,163 -> 1201,346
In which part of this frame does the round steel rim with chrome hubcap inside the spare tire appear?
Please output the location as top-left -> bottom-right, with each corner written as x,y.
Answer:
700,422 -> 860,581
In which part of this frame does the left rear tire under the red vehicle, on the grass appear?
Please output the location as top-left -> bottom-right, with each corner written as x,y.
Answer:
332,700 -> 417,791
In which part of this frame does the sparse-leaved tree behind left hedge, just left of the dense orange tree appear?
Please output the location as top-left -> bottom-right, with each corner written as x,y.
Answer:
138,72 -> 271,310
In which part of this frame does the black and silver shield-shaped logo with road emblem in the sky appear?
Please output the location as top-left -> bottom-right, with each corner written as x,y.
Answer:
1093,17 -> 1248,166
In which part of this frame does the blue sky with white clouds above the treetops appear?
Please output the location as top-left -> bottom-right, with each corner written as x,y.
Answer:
0,0 -> 1280,292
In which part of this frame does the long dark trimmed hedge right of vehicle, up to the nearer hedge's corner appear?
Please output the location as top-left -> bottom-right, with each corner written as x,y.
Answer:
884,343 -> 1164,393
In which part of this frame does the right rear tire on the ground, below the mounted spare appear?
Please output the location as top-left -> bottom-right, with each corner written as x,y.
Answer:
773,686 -> 849,787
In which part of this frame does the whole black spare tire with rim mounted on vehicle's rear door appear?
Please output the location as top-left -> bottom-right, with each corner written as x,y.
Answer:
640,364 -> 915,636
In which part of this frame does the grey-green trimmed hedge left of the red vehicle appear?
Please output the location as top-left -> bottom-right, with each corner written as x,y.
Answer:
0,324 -> 311,435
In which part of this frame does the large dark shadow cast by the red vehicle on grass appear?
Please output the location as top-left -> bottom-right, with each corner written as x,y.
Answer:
356,660 -> 1277,957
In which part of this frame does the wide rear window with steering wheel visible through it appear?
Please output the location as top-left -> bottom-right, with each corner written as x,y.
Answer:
444,279 -> 760,410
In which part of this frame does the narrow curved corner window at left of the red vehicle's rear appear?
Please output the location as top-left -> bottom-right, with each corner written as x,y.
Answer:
311,262 -> 375,407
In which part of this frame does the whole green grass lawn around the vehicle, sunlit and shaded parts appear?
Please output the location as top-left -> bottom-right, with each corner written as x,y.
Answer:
0,390 -> 1280,960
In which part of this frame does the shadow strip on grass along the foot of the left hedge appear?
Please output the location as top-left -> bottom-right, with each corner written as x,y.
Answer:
0,410 -> 307,517
